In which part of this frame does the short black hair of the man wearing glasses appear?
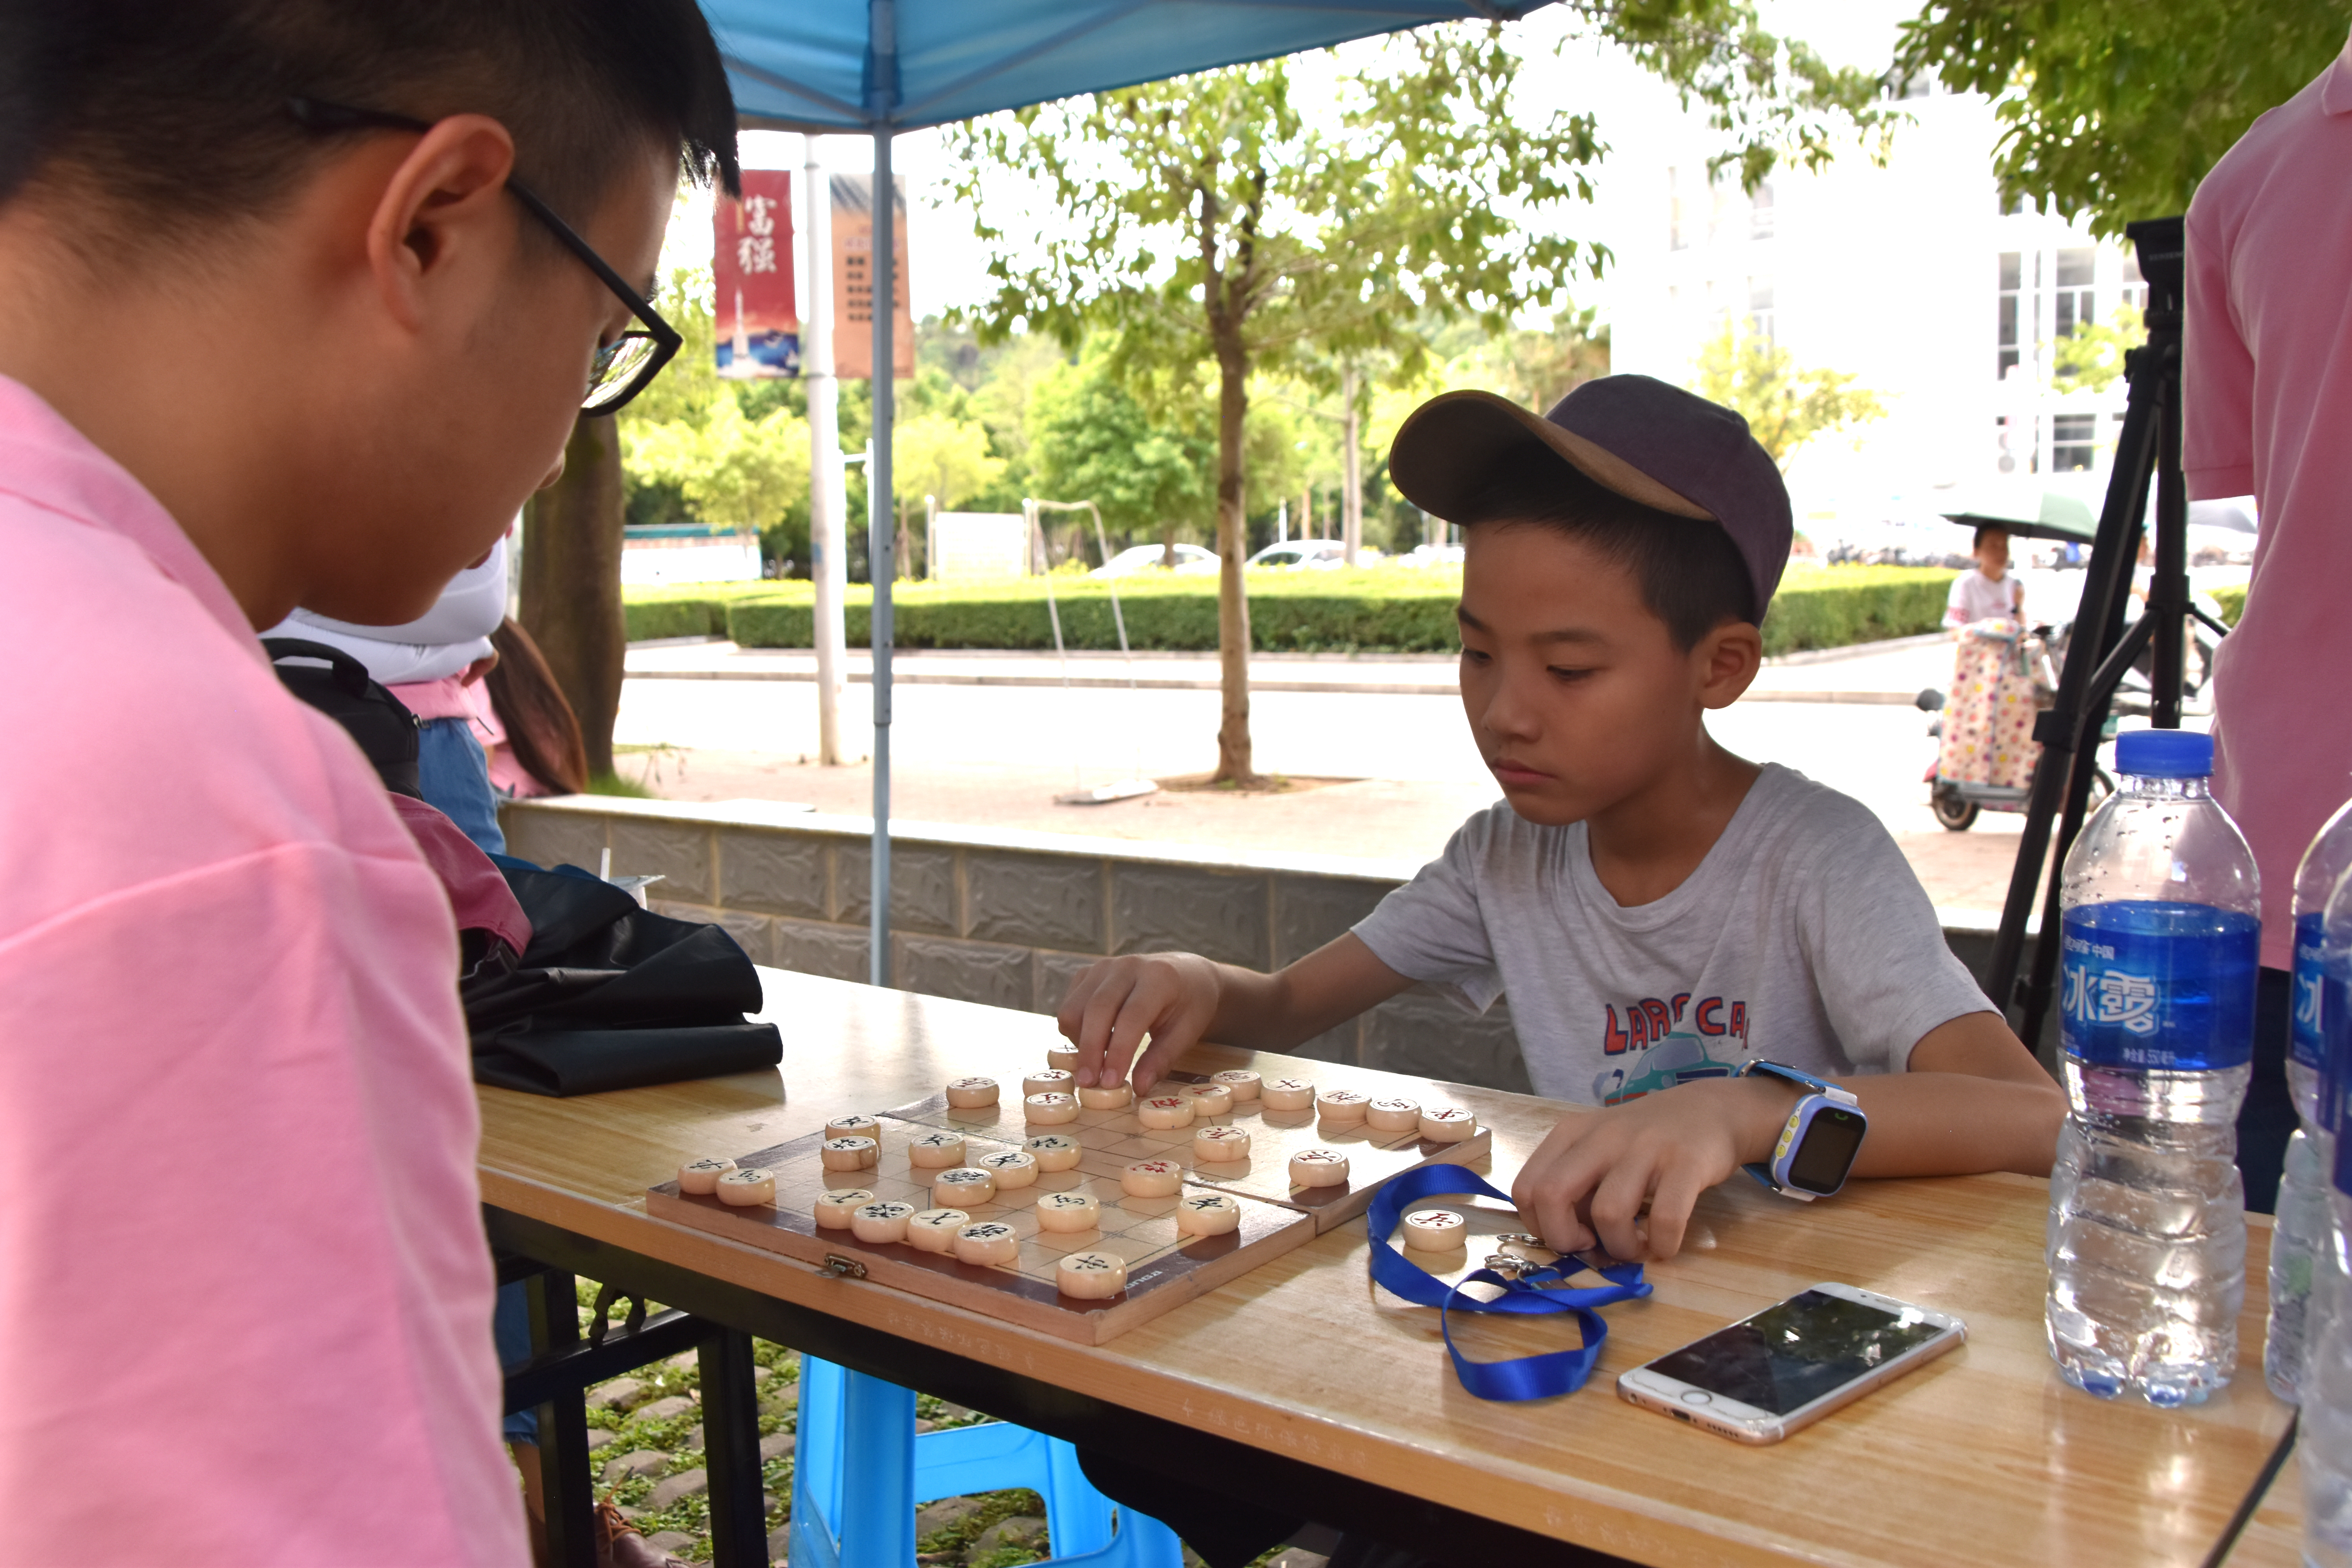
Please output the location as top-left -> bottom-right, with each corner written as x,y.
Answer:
0,0 -> 741,245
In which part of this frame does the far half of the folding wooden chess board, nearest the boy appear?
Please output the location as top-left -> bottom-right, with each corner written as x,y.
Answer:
889,1063 -> 1494,1234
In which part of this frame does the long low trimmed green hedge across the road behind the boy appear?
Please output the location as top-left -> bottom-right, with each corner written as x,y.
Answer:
628,566 -> 1952,653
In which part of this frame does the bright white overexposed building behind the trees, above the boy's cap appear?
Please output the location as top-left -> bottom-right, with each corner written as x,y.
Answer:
1611,82 -> 2145,548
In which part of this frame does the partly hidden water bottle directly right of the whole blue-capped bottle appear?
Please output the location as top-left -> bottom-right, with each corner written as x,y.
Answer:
2263,802 -> 2352,1403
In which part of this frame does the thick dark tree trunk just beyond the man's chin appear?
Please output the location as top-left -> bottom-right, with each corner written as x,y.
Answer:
522,416 -> 628,778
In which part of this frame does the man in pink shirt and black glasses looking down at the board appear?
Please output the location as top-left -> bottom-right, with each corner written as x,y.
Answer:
0,0 -> 736,1566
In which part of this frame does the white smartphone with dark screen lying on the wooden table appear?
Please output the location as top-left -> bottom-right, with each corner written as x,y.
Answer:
1618,1283 -> 1969,1443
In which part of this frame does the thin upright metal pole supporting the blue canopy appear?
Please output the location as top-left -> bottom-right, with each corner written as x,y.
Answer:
866,0 -> 898,985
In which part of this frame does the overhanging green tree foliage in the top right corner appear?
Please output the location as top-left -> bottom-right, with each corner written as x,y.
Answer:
1893,0 -> 2345,235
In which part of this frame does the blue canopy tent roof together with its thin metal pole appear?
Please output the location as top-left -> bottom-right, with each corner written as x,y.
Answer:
703,0 -> 1548,985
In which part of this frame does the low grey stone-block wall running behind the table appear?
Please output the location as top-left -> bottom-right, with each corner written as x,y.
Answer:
501,797 -> 2049,1091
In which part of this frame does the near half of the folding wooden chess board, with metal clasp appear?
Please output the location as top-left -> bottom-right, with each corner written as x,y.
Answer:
644,1114 -> 1315,1345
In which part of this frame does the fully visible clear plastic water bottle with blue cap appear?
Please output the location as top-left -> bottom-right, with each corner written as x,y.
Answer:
2044,729 -> 2263,1406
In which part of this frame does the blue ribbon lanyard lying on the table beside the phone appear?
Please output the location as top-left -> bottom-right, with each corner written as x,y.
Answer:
1364,1166 -> 1649,1399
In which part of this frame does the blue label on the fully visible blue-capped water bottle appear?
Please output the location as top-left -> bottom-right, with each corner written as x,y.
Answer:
2058,898 -> 2263,1072
